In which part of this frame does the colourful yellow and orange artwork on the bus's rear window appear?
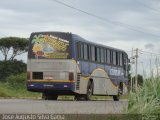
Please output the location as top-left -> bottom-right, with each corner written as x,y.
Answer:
32,34 -> 69,59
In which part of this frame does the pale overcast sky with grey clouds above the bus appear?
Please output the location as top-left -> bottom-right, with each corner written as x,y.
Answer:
0,0 -> 160,76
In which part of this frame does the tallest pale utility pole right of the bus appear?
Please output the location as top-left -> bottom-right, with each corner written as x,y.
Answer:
135,48 -> 138,91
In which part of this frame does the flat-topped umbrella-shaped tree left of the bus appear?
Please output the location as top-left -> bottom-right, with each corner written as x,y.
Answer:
0,37 -> 28,61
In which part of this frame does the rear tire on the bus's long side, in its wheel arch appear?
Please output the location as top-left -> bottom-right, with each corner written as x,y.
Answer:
85,81 -> 93,100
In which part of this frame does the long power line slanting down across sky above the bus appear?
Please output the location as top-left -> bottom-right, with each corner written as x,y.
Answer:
51,0 -> 160,37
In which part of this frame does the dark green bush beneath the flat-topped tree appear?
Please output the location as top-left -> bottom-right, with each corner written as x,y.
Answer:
0,60 -> 27,81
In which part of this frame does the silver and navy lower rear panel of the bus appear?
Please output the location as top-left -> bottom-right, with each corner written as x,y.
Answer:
27,59 -> 78,92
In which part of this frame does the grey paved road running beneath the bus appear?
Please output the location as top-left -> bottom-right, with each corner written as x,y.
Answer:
0,99 -> 128,114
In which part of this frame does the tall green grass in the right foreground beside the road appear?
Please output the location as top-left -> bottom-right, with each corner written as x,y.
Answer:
128,78 -> 160,115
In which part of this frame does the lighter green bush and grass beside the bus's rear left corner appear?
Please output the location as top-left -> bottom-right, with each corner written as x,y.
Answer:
0,73 -> 41,98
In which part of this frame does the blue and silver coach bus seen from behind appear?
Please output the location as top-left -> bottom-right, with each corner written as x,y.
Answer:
27,32 -> 128,101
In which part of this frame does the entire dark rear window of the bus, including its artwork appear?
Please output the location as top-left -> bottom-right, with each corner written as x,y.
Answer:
28,33 -> 70,59
